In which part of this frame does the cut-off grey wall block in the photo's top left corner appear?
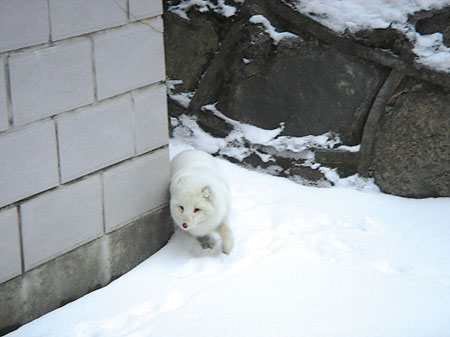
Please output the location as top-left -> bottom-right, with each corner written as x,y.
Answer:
0,0 -> 50,53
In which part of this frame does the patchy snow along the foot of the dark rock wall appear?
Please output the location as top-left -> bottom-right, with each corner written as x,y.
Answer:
171,104 -> 379,192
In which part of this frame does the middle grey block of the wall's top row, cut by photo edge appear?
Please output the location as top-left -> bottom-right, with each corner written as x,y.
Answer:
49,0 -> 128,41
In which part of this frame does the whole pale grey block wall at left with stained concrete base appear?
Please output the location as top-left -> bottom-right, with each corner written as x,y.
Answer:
0,0 -> 171,333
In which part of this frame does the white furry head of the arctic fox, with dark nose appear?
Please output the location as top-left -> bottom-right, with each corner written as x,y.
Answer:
170,177 -> 215,231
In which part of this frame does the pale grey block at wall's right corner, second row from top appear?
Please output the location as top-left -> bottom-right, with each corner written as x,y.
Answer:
94,17 -> 165,99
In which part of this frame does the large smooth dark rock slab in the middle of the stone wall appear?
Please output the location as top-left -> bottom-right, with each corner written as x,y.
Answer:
218,40 -> 385,145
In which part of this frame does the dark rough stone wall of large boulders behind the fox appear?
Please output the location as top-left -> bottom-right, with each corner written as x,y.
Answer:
165,0 -> 450,197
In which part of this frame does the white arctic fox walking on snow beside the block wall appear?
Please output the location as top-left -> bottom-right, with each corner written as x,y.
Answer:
170,150 -> 233,254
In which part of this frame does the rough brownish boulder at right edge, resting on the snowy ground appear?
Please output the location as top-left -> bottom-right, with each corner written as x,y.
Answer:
372,80 -> 450,197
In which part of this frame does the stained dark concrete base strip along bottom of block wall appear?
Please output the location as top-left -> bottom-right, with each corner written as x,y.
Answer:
0,208 -> 173,336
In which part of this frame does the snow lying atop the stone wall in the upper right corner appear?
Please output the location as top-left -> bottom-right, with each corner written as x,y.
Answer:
287,0 -> 450,72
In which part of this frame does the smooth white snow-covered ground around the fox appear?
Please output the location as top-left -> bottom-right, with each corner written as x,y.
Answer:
8,139 -> 450,337
